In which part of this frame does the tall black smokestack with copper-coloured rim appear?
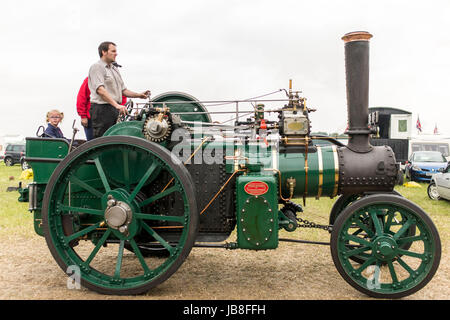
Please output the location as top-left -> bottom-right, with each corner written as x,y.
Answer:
342,31 -> 372,152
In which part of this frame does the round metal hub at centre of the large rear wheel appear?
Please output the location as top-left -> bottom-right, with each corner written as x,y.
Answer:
105,196 -> 132,235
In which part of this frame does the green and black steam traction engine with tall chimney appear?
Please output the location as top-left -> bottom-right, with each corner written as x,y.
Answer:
19,32 -> 441,298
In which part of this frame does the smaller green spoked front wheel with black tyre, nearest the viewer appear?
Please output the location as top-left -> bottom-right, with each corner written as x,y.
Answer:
331,195 -> 441,298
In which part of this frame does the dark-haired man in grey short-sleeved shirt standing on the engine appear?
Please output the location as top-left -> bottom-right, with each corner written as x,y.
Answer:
88,41 -> 150,138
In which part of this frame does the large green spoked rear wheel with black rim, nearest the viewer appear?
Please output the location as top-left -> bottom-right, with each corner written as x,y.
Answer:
42,136 -> 198,295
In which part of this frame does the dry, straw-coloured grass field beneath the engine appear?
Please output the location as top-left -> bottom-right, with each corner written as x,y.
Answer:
0,163 -> 450,300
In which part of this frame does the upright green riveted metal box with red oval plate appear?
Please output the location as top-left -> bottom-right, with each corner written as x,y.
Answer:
236,174 -> 278,250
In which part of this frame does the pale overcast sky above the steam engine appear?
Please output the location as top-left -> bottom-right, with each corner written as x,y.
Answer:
0,0 -> 450,138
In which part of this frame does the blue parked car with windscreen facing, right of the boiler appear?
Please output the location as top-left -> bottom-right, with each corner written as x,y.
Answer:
405,151 -> 447,182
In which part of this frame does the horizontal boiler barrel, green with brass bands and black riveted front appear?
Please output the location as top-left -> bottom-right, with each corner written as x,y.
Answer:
278,146 -> 397,199
